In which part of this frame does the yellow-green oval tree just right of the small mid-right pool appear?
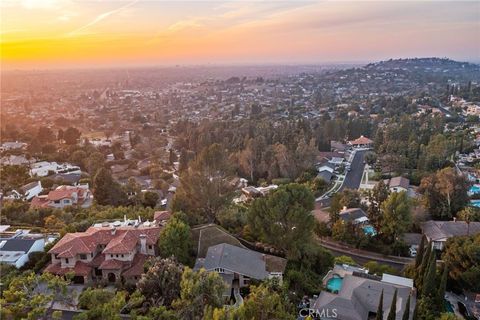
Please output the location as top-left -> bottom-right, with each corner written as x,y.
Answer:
380,191 -> 412,243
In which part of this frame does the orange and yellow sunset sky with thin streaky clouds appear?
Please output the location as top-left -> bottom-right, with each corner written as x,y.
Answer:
0,0 -> 480,69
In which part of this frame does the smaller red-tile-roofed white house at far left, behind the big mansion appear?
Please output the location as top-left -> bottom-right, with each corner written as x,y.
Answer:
30,185 -> 93,209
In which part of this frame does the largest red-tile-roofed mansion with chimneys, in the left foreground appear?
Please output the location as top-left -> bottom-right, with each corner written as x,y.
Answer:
44,226 -> 161,283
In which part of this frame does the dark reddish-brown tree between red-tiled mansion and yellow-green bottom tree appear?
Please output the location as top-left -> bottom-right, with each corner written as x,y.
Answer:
137,258 -> 184,308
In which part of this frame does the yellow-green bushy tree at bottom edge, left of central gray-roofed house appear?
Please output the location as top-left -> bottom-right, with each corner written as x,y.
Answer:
173,267 -> 225,320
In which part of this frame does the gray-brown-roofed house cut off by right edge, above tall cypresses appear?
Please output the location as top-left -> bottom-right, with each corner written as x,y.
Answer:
420,220 -> 480,250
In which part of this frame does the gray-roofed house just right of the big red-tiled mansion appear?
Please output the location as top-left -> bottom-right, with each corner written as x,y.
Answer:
194,243 -> 287,296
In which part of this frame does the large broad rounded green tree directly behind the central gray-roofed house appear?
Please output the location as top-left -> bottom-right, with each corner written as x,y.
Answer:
248,183 -> 315,257
